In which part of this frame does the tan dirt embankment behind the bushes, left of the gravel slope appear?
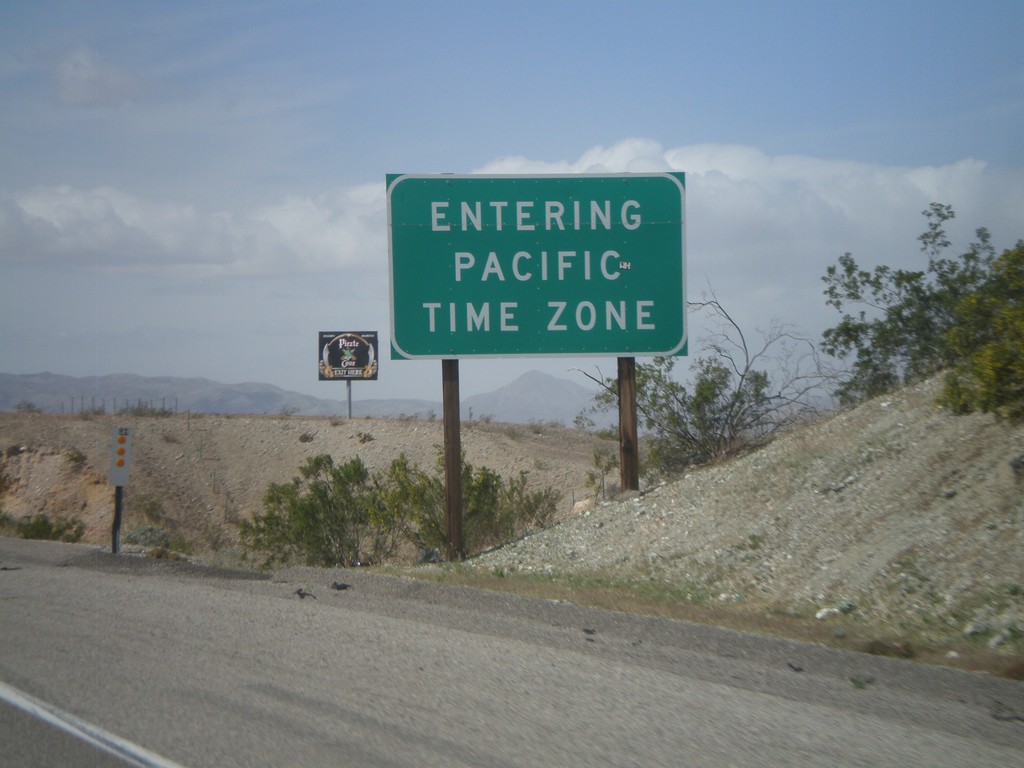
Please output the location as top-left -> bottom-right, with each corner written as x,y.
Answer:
0,413 -> 609,561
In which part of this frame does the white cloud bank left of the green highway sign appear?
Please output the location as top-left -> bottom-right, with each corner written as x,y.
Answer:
0,184 -> 386,278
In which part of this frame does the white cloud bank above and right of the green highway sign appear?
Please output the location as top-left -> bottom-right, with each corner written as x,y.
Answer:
468,139 -> 1024,354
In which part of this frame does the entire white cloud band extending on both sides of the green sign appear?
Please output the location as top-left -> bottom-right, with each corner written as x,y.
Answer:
0,139 -> 1024,342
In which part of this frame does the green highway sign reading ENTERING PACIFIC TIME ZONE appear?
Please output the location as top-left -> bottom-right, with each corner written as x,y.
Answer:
387,173 -> 686,358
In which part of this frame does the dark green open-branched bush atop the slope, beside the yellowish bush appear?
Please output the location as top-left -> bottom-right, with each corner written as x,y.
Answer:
821,203 -> 994,403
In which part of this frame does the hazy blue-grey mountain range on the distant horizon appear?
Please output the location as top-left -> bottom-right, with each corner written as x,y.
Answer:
0,371 -> 595,425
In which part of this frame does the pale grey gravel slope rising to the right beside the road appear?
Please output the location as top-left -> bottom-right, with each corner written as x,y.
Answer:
468,381 -> 1024,648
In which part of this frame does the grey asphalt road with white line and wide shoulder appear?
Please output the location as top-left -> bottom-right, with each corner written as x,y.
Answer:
0,539 -> 1024,768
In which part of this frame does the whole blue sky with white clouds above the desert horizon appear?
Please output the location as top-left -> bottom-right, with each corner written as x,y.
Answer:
0,0 -> 1024,400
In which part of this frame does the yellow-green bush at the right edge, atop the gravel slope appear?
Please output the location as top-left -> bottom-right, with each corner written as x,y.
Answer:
942,241 -> 1024,420
